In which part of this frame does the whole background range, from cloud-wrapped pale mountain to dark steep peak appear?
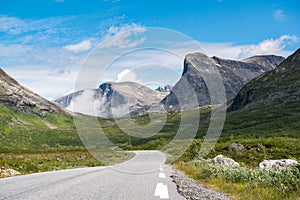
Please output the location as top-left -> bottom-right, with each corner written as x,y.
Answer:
55,53 -> 284,118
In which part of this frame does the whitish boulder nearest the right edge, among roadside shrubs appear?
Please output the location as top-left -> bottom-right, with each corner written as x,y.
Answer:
259,159 -> 298,170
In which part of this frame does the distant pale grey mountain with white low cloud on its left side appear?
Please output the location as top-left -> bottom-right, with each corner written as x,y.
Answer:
55,82 -> 168,118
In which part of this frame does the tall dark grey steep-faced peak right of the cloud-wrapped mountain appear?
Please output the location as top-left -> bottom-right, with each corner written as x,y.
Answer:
161,53 -> 284,110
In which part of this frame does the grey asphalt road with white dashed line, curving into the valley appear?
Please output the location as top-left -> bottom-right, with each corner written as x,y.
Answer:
0,151 -> 184,200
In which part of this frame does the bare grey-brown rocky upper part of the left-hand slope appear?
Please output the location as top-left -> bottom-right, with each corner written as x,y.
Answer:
0,69 -> 66,116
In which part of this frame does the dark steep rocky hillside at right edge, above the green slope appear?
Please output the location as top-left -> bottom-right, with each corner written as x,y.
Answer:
229,49 -> 300,112
